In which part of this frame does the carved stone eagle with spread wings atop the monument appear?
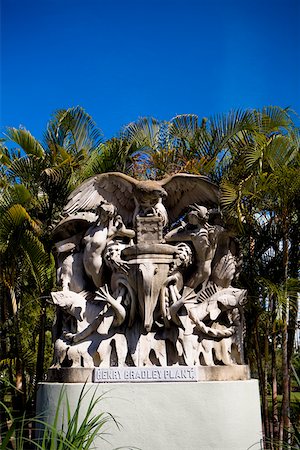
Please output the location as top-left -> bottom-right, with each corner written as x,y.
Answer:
64,172 -> 219,225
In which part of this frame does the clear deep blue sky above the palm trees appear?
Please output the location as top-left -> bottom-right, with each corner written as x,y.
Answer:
1,0 -> 300,138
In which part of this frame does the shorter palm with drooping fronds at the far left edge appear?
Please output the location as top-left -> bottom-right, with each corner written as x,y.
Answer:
0,185 -> 53,414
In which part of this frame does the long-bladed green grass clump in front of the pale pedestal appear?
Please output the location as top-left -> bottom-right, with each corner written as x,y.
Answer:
0,385 -> 119,450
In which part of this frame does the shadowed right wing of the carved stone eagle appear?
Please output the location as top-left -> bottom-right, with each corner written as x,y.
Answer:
159,173 -> 219,221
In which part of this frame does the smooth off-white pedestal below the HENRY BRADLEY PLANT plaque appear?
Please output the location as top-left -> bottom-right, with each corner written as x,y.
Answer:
37,380 -> 262,450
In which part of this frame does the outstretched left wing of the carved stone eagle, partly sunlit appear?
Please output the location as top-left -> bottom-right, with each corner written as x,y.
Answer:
64,172 -> 137,224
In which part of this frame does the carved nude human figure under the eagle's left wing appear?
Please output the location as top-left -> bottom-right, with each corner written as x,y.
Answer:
83,203 -> 135,288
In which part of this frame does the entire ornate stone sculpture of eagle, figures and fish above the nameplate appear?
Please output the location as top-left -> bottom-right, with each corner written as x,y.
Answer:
52,173 -> 246,368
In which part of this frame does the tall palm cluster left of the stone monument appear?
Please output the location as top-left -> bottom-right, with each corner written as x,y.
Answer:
0,107 -> 101,414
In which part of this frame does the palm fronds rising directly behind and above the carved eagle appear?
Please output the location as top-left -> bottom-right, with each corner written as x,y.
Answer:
121,111 -> 255,181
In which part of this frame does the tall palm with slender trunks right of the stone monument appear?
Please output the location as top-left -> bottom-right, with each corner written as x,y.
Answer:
221,107 -> 300,445
